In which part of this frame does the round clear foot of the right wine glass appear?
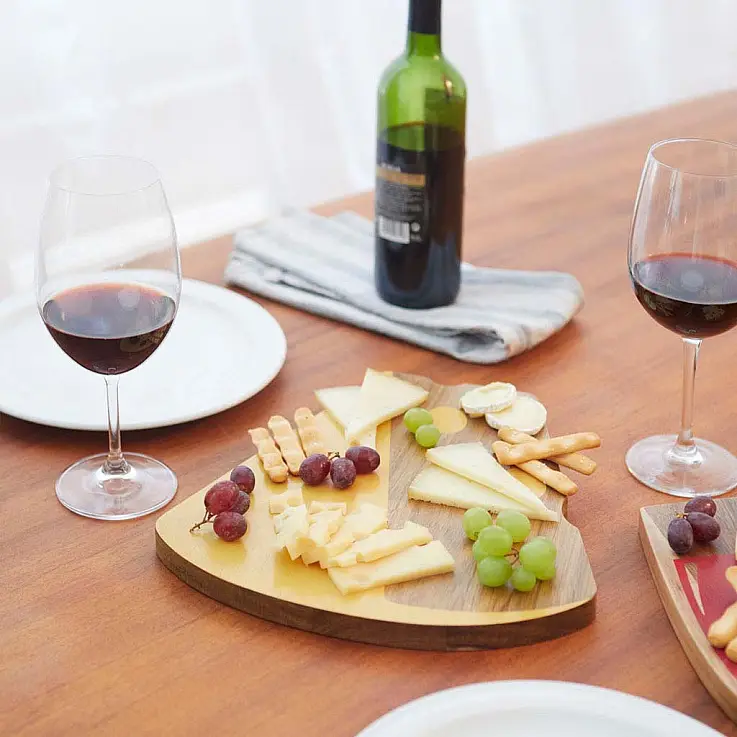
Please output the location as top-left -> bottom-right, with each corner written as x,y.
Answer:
625,435 -> 737,498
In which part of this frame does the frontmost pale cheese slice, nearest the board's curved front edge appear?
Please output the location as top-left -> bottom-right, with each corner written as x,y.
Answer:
328,540 -> 455,595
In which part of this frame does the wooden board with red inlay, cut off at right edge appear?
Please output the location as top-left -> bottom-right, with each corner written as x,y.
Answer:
640,499 -> 737,722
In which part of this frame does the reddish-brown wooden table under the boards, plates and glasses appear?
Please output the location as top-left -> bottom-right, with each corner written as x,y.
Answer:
0,93 -> 737,737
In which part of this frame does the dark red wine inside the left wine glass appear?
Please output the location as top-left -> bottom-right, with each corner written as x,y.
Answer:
41,283 -> 176,375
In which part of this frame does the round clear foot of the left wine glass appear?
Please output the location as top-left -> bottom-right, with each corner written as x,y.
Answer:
56,453 -> 177,520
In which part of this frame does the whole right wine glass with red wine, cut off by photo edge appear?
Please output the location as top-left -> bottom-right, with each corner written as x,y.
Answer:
626,139 -> 737,497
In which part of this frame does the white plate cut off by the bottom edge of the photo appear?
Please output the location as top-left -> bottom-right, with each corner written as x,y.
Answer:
358,681 -> 722,737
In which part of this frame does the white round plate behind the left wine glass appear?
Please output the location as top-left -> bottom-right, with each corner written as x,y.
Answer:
0,279 -> 287,430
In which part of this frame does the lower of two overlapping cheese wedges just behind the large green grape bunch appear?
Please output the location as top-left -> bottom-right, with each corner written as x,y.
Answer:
408,466 -> 558,522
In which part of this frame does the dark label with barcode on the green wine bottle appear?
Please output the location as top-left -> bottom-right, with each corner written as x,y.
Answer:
375,152 -> 428,245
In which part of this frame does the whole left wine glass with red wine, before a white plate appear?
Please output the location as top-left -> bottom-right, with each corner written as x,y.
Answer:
36,156 -> 182,520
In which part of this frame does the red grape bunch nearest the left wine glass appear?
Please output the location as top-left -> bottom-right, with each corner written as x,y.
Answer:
190,466 -> 256,542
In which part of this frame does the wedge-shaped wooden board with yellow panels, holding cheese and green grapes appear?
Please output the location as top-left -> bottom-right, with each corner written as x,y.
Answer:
156,374 -> 596,650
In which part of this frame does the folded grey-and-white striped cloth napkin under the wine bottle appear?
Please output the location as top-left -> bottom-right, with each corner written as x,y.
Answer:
225,211 -> 583,363
